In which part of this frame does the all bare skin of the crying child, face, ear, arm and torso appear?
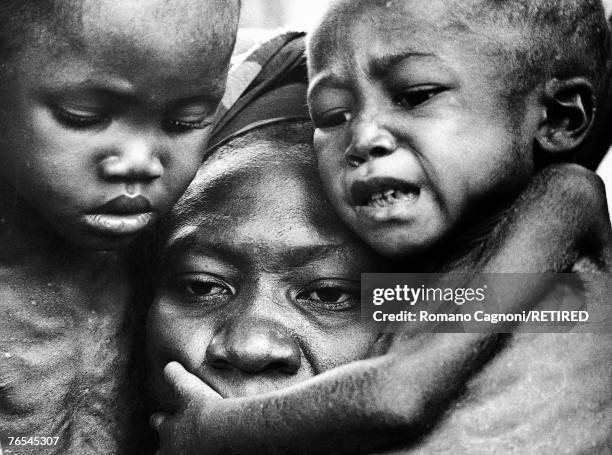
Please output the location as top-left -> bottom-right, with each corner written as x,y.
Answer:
152,1 -> 612,454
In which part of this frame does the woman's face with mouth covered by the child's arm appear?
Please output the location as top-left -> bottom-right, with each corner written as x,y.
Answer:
147,130 -> 388,397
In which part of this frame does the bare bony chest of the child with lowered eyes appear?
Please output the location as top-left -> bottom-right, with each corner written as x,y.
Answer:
0,195 -> 139,454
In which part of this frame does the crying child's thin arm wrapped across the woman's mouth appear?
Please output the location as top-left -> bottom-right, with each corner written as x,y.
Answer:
153,165 -> 612,455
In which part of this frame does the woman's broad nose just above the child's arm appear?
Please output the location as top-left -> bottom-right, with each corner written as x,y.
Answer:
206,317 -> 301,374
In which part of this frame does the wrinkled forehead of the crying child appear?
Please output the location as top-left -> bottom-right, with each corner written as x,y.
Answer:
309,10 -> 509,91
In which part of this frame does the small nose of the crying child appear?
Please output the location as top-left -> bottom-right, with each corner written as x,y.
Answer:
344,119 -> 397,167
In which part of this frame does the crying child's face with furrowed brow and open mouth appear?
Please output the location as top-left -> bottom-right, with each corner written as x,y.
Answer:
309,1 -> 535,255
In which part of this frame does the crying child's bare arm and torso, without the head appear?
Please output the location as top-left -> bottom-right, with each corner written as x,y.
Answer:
154,166 -> 612,454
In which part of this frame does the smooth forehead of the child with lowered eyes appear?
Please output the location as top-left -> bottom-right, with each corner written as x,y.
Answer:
5,0 -> 238,99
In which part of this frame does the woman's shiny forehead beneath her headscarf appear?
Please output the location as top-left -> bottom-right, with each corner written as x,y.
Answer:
163,127 -> 366,253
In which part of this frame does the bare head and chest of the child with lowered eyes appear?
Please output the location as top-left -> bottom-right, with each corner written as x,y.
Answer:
0,0 -> 238,455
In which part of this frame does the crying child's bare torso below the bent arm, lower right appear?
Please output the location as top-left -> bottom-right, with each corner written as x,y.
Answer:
401,333 -> 612,454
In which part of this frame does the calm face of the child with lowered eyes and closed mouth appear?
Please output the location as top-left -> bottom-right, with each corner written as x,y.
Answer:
0,0 -> 237,249
